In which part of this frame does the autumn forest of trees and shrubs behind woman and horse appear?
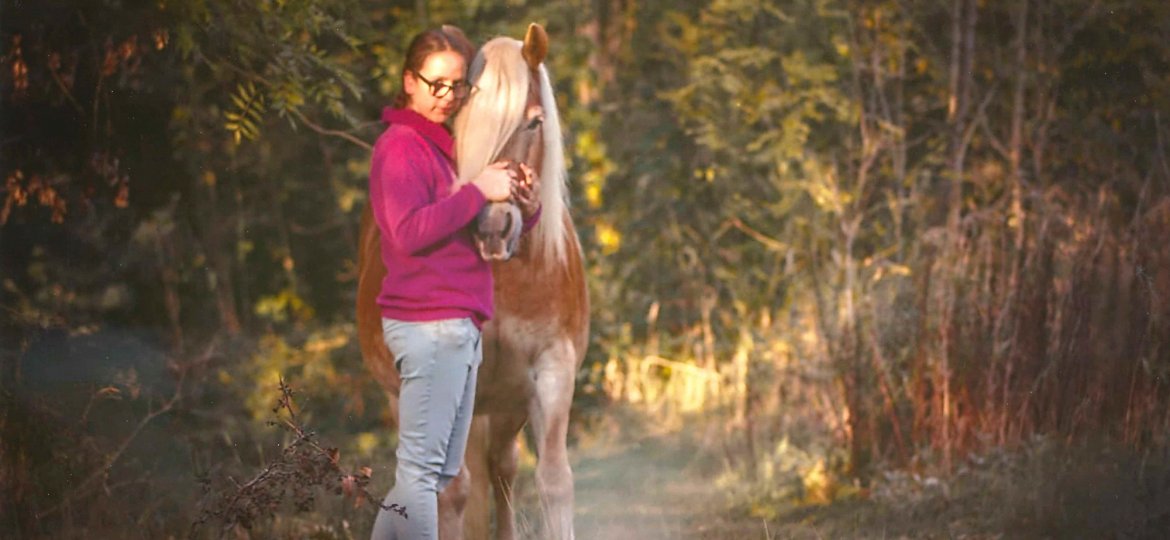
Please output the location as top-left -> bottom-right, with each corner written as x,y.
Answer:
0,0 -> 1170,538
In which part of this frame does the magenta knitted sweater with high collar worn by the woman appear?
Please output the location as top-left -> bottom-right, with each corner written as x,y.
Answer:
370,108 -> 493,327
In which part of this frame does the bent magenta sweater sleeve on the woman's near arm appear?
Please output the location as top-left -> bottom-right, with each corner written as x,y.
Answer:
376,132 -> 487,255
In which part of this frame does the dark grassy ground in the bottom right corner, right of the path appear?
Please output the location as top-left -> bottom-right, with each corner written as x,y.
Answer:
706,439 -> 1170,539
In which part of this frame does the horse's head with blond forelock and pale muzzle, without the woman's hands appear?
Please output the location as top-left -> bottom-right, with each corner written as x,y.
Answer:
455,23 -> 559,261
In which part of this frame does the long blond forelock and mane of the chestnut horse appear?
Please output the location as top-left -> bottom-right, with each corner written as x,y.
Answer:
455,37 -> 569,264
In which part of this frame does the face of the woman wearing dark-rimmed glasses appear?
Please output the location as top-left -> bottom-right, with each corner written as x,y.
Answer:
402,50 -> 468,124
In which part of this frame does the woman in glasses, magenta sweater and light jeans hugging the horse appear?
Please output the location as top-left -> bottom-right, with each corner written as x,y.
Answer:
370,26 -> 538,540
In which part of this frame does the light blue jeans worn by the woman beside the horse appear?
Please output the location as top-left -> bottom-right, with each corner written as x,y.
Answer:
371,319 -> 483,540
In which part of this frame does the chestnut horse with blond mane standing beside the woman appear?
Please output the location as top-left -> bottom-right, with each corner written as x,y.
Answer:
357,23 -> 589,540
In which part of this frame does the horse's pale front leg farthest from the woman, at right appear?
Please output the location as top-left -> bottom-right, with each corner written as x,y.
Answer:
529,339 -> 577,540
